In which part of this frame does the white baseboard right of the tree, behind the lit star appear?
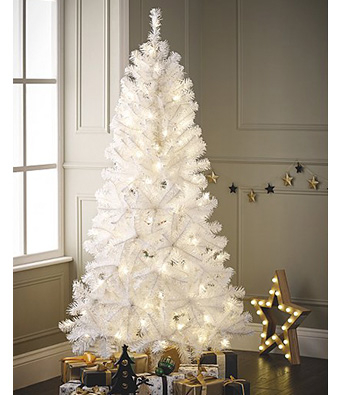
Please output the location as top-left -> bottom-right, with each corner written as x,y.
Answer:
231,323 -> 328,359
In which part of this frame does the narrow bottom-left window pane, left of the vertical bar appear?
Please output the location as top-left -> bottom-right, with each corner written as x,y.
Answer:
13,173 -> 24,256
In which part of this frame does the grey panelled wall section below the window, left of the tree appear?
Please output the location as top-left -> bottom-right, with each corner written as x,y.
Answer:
13,263 -> 70,355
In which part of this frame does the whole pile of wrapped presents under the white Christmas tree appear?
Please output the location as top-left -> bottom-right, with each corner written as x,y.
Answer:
59,351 -> 250,395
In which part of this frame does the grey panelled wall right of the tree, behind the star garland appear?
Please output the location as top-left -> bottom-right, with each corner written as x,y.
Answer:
130,0 -> 328,329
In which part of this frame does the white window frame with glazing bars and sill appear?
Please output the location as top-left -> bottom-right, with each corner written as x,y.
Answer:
13,0 -> 64,267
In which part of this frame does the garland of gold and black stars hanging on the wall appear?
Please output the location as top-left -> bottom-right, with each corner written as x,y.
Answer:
206,161 -> 328,203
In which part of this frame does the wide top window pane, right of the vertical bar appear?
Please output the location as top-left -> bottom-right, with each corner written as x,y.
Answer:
26,0 -> 57,78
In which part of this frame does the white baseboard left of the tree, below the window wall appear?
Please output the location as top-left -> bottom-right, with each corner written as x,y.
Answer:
13,342 -> 72,390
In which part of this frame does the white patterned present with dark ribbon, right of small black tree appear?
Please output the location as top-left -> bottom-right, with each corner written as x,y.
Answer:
137,372 -> 185,395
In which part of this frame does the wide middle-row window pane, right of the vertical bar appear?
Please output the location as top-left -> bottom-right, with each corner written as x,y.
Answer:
26,84 -> 57,165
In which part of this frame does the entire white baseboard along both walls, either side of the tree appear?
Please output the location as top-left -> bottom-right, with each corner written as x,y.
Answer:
13,323 -> 328,390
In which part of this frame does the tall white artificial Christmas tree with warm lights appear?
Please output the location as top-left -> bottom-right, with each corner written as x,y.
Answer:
60,9 -> 250,360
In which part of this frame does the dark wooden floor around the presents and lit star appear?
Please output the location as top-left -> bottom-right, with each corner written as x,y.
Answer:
13,351 -> 328,395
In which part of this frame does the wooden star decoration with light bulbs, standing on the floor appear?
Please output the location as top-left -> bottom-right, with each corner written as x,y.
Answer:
251,270 -> 311,365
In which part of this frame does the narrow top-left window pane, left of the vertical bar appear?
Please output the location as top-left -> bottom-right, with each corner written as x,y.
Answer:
13,0 -> 23,78
